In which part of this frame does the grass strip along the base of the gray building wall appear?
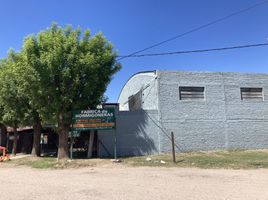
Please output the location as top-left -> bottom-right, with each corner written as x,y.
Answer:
124,150 -> 268,169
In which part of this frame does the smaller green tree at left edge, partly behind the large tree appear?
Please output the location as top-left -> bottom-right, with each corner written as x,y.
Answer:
0,51 -> 41,156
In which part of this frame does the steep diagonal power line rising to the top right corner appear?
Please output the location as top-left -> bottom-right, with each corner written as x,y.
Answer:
117,0 -> 268,61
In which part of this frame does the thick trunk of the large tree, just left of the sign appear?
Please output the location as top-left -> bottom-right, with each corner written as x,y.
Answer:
58,113 -> 70,160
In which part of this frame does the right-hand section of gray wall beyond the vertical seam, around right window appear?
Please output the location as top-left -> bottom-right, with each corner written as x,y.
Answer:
223,73 -> 268,149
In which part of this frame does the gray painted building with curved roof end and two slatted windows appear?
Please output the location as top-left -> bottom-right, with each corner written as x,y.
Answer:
107,71 -> 268,156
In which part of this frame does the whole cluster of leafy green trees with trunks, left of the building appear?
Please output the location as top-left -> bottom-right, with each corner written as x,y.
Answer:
0,23 -> 121,160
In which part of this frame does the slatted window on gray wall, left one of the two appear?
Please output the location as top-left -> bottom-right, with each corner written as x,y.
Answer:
179,87 -> 205,100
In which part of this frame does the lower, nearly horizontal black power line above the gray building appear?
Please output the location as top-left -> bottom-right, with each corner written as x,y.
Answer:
118,43 -> 268,58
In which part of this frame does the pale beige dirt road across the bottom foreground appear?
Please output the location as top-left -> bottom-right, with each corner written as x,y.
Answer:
0,163 -> 268,200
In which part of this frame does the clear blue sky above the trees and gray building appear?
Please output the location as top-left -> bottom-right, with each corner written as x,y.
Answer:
0,0 -> 268,102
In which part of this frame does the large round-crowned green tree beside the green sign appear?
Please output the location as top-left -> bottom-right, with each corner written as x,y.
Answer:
22,24 -> 120,159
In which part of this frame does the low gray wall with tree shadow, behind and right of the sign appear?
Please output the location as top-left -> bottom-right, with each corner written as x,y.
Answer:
98,110 -> 160,157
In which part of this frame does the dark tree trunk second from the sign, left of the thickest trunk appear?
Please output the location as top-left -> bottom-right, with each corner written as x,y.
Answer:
32,119 -> 42,156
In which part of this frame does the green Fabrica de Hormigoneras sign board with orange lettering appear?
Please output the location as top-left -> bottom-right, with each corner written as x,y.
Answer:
73,108 -> 115,131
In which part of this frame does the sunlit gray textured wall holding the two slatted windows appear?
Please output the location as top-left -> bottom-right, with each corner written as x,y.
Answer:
158,71 -> 268,152
